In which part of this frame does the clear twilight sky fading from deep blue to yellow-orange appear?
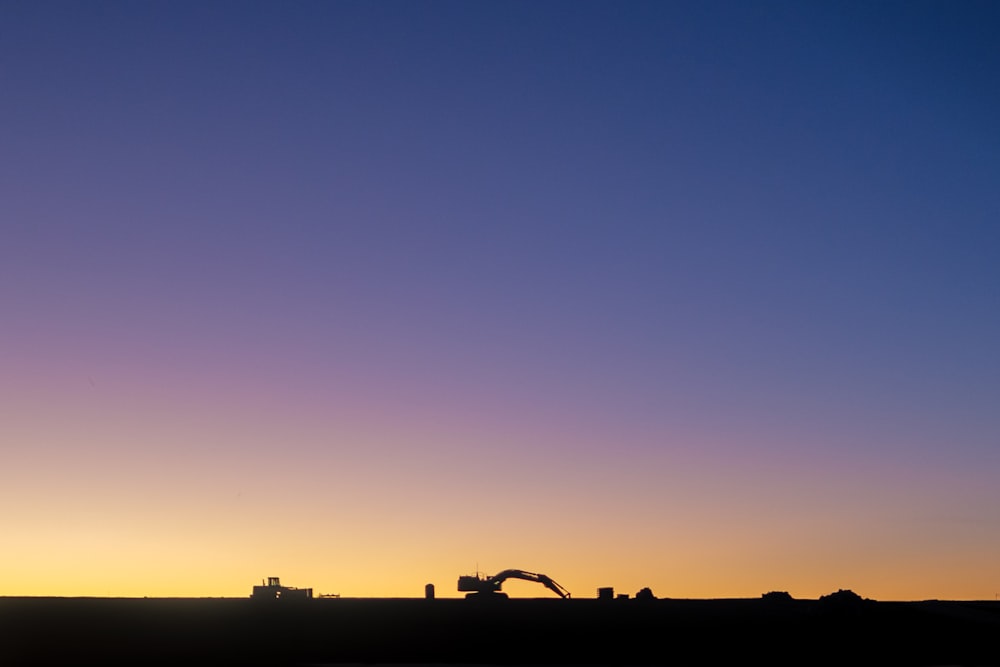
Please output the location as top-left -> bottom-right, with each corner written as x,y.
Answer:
0,0 -> 1000,600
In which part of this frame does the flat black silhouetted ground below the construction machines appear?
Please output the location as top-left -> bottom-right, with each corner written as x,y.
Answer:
0,598 -> 1000,667
